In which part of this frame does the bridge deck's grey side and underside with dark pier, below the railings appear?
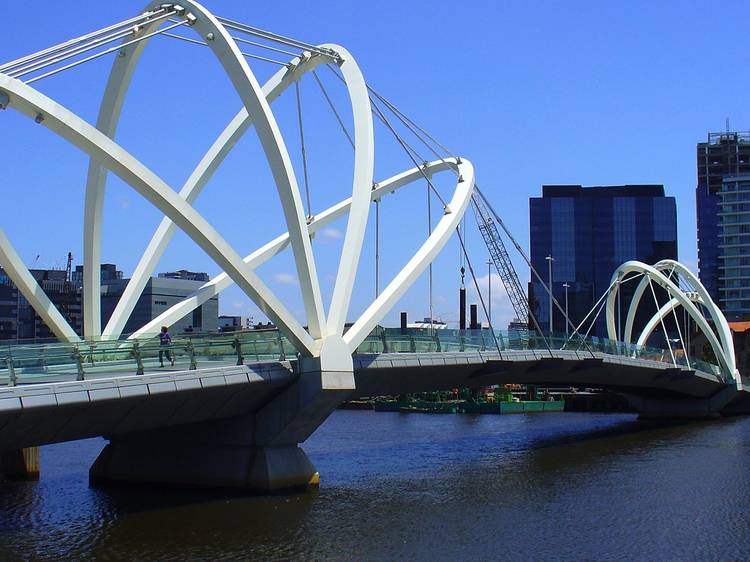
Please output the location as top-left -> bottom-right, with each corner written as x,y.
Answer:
0,350 -> 750,491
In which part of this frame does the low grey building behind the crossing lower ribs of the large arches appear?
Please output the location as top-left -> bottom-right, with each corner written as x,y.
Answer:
102,274 -> 219,335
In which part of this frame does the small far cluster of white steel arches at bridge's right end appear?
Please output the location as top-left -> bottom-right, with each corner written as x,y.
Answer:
607,260 -> 740,384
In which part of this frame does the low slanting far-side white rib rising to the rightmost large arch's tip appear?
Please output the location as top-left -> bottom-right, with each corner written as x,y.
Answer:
125,158 -> 465,339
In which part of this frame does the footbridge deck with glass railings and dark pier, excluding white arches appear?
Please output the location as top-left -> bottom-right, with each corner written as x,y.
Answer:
0,328 -> 745,488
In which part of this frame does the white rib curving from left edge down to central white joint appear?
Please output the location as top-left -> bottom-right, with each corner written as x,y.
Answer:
0,74 -> 317,355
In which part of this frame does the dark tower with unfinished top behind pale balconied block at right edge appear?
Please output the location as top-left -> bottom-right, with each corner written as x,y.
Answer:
695,132 -> 750,303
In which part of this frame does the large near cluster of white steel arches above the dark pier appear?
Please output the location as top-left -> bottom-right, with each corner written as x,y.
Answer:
0,0 -> 474,363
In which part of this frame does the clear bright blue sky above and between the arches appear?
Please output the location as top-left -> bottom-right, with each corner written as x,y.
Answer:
0,0 -> 750,330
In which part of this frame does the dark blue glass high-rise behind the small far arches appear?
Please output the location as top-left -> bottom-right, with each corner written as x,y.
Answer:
529,185 -> 677,337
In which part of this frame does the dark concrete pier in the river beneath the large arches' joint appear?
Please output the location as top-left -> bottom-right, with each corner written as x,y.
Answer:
89,350 -> 354,493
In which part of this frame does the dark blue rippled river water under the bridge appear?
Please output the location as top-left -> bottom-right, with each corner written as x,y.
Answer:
0,411 -> 750,560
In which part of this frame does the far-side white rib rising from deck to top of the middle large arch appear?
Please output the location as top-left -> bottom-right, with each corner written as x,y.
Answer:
102,55 -> 328,337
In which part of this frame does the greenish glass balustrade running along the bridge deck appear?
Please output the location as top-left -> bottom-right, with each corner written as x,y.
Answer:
0,327 -> 722,385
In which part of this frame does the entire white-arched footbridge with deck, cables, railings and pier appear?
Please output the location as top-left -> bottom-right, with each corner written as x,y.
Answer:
0,0 -> 745,490
